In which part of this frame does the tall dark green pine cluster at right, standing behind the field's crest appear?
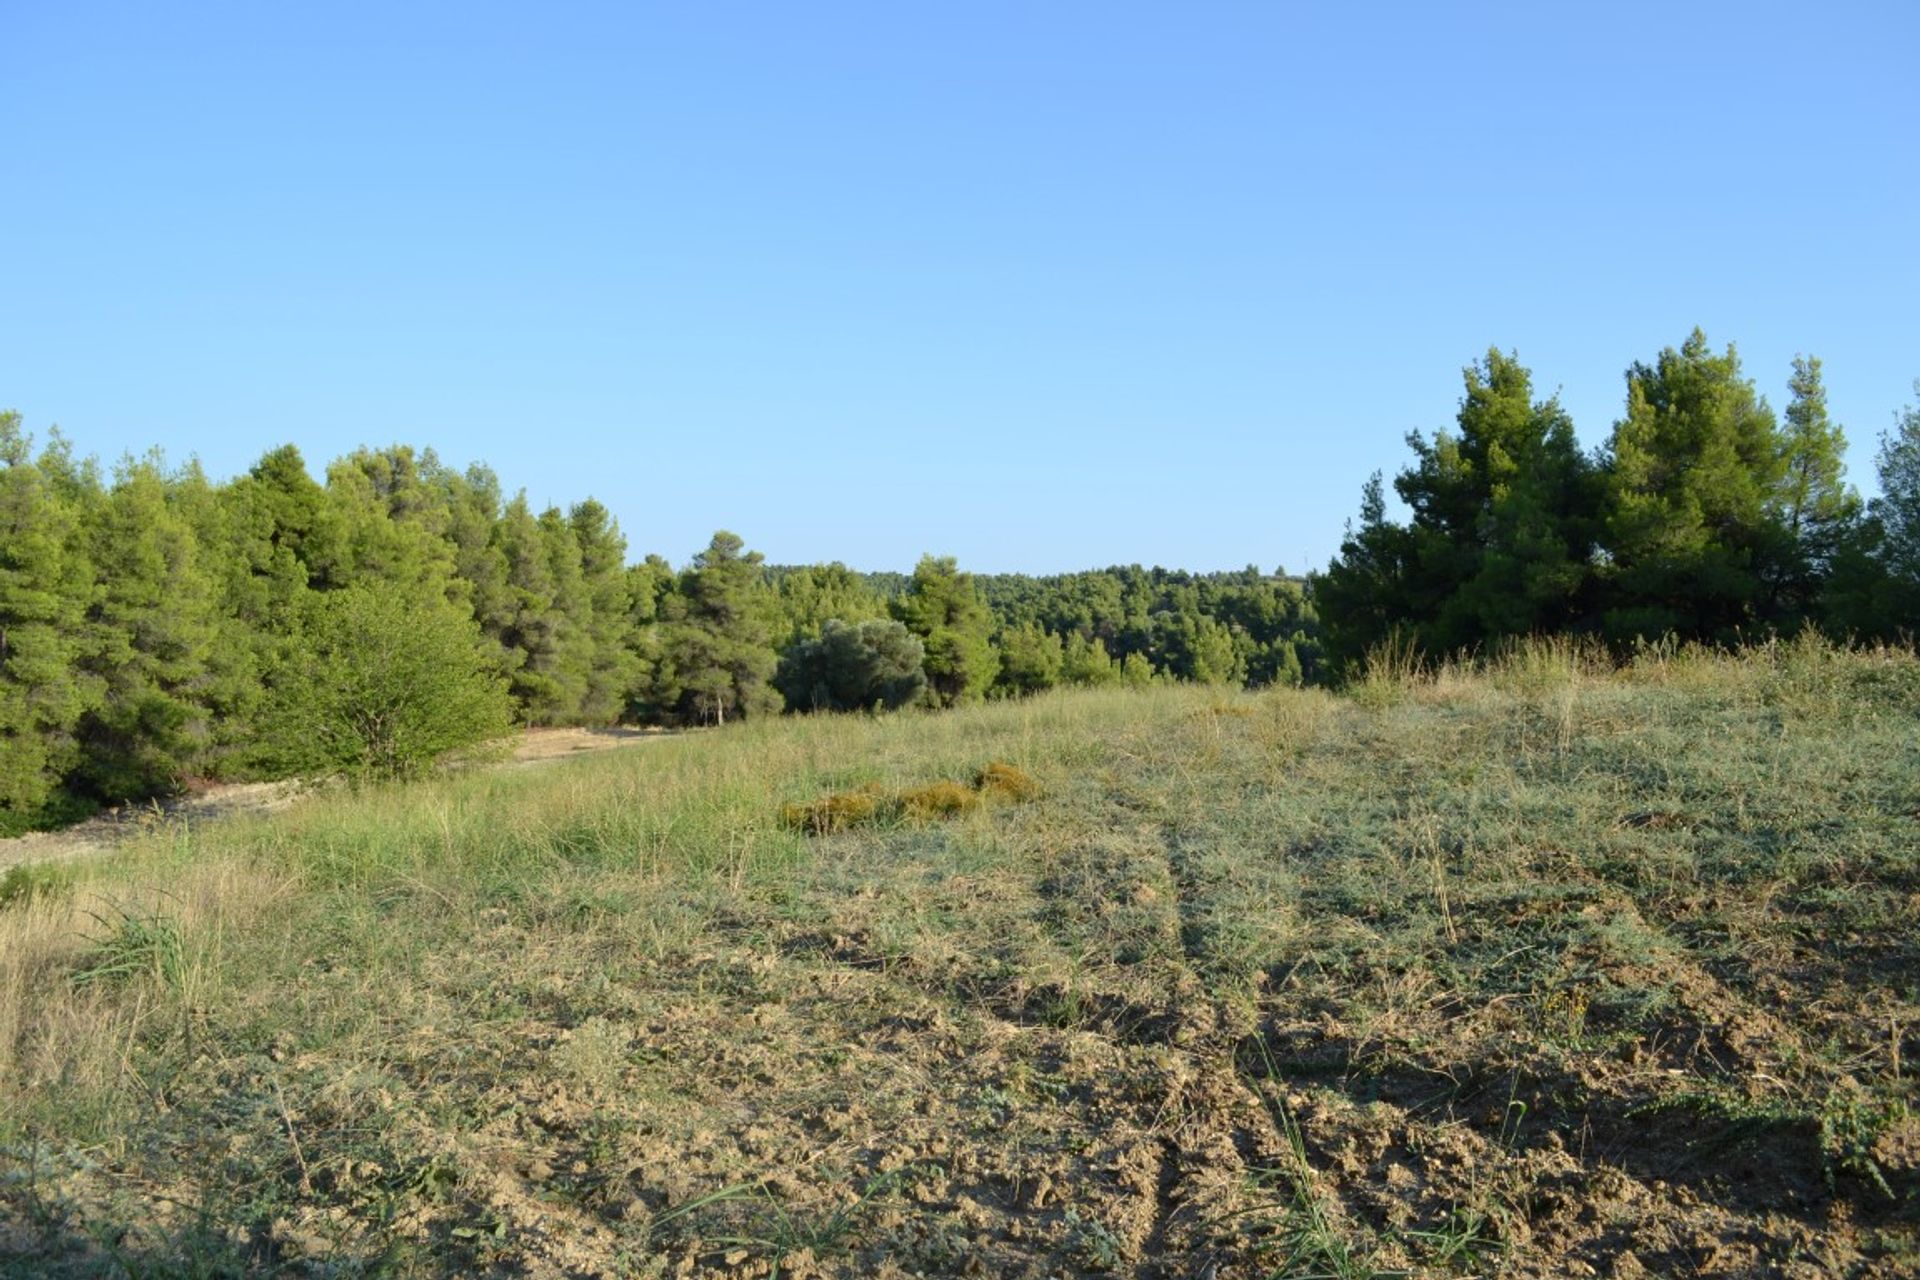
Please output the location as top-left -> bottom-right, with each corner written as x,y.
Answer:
1311,330 -> 1920,677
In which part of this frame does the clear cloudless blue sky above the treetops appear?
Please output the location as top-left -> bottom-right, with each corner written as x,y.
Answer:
0,0 -> 1920,572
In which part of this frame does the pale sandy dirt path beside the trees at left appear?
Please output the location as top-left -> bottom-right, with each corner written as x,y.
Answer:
0,727 -> 666,871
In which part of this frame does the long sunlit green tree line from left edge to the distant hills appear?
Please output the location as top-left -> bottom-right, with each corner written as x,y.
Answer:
0,413 -> 1317,833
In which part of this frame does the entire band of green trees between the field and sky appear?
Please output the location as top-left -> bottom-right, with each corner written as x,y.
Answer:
0,332 -> 1920,835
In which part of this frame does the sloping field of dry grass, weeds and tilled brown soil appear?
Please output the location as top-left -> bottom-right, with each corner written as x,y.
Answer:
0,645 -> 1920,1280
